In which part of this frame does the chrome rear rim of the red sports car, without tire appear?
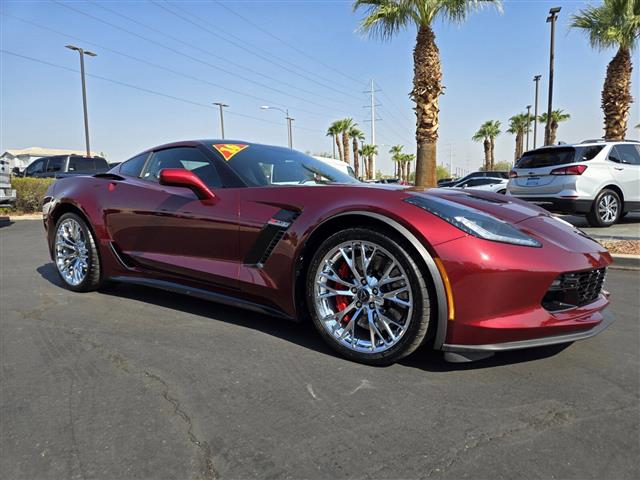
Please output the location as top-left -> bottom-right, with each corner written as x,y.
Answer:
55,218 -> 89,286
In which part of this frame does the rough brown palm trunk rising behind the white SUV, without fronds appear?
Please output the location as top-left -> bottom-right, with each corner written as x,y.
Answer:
602,48 -> 633,140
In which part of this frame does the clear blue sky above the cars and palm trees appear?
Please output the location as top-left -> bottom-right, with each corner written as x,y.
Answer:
0,0 -> 640,172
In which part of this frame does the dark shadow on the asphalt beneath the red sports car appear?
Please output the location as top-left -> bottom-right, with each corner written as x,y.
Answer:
37,262 -> 568,373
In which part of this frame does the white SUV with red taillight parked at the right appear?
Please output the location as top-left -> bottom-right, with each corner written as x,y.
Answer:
507,140 -> 640,227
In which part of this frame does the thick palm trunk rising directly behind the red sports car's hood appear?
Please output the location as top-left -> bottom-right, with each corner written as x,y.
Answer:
411,26 -> 444,187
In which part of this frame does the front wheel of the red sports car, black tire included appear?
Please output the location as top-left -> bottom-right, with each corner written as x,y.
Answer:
306,228 -> 431,365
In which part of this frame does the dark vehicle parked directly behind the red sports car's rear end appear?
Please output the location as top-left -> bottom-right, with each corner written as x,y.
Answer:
22,155 -> 109,178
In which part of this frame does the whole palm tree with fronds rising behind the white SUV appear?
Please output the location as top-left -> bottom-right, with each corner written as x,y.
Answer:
571,0 -> 640,140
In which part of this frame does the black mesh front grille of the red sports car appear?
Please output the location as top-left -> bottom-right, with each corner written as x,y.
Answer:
542,268 -> 607,312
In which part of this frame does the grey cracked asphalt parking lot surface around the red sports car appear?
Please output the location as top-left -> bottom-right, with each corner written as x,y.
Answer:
0,221 -> 640,479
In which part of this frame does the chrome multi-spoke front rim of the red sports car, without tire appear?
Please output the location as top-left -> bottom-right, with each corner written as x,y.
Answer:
314,240 -> 413,353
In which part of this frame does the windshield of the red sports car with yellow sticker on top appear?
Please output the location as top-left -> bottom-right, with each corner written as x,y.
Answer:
211,144 -> 358,187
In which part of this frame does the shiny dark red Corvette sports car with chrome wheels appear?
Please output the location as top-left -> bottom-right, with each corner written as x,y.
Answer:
43,140 -> 612,364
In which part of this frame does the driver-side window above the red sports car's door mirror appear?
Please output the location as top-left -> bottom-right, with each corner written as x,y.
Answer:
142,147 -> 222,188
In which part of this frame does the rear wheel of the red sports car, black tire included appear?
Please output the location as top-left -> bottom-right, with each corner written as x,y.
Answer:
52,213 -> 102,292
